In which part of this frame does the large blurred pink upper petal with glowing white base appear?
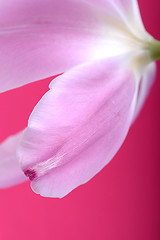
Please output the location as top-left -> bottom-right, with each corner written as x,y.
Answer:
0,0 -> 149,92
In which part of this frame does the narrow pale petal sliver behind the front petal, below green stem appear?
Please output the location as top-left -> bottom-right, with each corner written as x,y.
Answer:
134,63 -> 156,120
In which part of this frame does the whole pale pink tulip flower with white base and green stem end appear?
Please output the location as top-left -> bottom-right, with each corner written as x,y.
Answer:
0,0 -> 160,197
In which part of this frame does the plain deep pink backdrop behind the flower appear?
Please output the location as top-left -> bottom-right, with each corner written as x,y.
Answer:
0,0 -> 160,240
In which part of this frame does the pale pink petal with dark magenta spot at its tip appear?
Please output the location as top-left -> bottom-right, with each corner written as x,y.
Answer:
18,58 -> 136,197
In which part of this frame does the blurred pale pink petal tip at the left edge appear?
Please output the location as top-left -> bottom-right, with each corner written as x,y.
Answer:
0,132 -> 27,188
